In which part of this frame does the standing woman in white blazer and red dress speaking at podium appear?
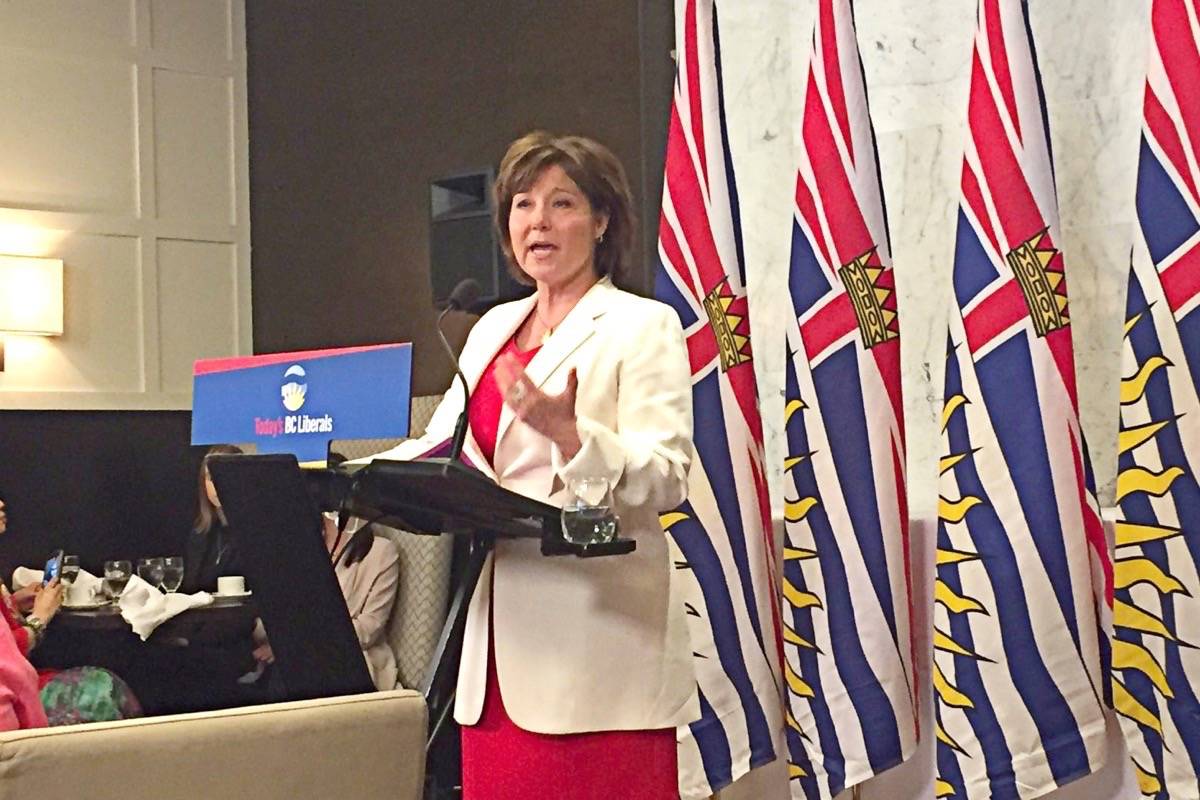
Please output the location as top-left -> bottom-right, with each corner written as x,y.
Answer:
369,132 -> 700,800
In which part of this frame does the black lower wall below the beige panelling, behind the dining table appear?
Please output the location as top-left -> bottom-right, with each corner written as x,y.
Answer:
0,411 -> 203,583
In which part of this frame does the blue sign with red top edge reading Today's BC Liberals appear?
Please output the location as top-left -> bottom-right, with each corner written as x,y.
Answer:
192,344 -> 413,462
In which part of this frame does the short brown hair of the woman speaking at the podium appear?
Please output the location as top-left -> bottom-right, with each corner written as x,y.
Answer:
496,131 -> 636,285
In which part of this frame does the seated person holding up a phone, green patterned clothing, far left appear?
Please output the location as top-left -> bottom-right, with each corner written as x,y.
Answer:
0,500 -> 142,727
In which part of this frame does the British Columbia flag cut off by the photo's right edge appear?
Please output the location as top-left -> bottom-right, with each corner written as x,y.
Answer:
1112,0 -> 1200,800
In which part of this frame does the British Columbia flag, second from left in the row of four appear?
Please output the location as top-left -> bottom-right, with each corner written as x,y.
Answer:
782,0 -> 917,800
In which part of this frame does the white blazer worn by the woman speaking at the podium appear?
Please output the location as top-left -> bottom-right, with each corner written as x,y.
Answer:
376,278 -> 700,734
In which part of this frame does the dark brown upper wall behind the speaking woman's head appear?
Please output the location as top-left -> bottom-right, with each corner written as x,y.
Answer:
246,0 -> 671,395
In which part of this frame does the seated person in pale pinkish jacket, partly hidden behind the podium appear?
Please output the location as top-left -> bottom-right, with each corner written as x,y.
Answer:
254,515 -> 400,691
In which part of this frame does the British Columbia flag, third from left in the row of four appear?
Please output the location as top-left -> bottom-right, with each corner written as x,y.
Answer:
932,0 -> 1112,799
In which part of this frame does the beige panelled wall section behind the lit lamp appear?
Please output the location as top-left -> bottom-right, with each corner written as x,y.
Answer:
0,0 -> 252,409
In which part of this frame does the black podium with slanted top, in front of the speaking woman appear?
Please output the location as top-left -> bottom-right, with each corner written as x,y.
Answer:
209,456 -> 636,799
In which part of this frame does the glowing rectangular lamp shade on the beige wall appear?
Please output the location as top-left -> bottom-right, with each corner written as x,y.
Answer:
0,255 -> 62,336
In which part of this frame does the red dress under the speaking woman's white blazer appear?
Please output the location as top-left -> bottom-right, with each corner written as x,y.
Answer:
462,339 -> 679,800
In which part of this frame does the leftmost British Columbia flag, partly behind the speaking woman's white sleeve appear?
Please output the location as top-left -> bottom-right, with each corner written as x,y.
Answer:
655,0 -> 782,800
